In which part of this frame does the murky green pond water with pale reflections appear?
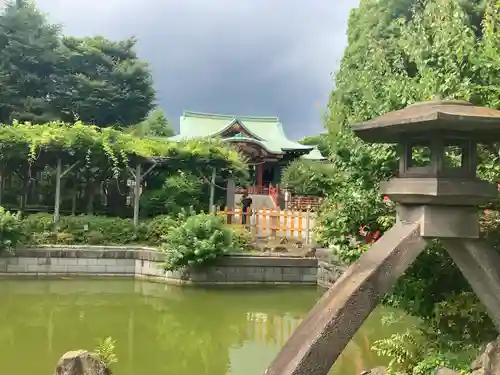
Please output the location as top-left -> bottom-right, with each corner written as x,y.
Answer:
0,279 -> 413,375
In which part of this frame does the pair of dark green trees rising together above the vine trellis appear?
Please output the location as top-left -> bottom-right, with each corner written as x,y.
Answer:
0,0 -> 155,127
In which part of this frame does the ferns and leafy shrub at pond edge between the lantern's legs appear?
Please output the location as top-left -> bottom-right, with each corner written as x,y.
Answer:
372,293 -> 482,375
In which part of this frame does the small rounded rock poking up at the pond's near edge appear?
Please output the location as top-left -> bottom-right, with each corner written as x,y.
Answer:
54,350 -> 112,375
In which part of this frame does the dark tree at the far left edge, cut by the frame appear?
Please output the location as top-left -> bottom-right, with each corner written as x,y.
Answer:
0,0 -> 61,123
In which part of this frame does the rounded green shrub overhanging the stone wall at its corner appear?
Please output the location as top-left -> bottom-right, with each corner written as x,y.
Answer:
162,213 -> 232,271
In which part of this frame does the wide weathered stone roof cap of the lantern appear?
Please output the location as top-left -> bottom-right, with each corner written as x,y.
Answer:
352,99 -> 500,143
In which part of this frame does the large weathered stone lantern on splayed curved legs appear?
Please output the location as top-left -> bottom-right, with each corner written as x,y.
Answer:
266,100 -> 500,375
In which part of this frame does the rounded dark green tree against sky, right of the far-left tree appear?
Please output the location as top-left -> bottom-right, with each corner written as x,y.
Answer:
56,36 -> 155,127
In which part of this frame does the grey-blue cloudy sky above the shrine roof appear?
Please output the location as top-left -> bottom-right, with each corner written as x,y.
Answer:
37,0 -> 359,139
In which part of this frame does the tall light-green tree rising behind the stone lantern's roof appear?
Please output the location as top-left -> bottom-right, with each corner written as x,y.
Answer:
318,0 -> 500,247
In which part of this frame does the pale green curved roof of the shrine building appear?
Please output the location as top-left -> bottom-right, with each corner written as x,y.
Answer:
169,111 -> 325,160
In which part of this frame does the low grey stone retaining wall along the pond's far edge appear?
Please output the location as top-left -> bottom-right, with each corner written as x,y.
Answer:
0,246 -> 318,285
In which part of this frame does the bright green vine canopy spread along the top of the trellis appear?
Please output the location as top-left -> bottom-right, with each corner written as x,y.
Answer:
0,122 -> 246,177
